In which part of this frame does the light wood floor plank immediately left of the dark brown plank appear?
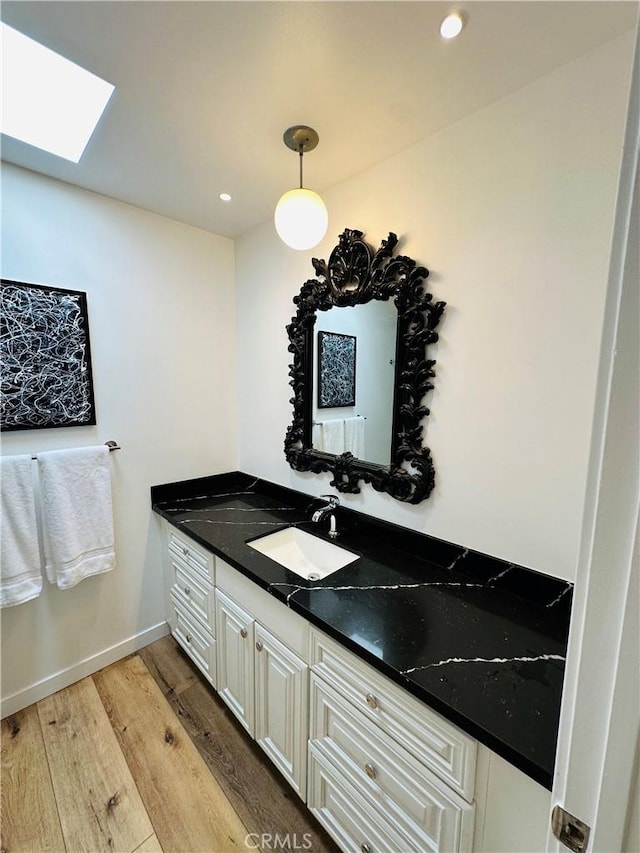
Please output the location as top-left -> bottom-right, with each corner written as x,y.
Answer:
93,656 -> 248,853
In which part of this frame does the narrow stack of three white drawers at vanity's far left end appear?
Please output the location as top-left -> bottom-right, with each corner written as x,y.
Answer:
166,529 -> 216,687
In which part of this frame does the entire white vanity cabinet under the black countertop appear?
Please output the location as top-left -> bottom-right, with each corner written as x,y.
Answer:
160,524 -> 551,853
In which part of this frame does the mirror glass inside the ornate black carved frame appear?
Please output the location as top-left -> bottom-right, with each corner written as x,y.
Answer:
311,300 -> 398,465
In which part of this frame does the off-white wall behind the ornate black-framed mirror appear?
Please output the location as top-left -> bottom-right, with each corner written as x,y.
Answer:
236,35 -> 633,580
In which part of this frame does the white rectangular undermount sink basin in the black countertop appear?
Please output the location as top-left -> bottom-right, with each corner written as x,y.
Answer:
247,527 -> 358,581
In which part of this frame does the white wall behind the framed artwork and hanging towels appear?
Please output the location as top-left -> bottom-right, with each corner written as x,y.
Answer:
1,164 -> 236,714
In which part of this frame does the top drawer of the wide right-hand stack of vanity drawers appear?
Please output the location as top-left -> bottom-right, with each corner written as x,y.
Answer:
310,629 -> 477,802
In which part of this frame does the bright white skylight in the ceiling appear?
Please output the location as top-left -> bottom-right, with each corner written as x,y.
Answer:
1,23 -> 115,163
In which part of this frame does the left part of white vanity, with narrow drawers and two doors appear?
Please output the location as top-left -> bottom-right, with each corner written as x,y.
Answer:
165,524 -> 309,800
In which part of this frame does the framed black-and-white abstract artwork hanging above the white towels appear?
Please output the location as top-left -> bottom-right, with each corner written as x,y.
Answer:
0,279 -> 96,431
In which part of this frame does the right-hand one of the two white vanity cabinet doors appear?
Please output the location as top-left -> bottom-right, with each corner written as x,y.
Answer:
255,623 -> 308,800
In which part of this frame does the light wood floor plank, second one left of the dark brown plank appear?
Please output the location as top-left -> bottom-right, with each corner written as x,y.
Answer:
37,678 -> 153,853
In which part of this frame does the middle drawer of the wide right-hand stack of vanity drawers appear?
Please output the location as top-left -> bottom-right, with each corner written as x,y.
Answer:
309,674 -> 474,851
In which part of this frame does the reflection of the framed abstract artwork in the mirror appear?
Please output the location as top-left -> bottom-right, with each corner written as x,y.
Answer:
318,332 -> 356,409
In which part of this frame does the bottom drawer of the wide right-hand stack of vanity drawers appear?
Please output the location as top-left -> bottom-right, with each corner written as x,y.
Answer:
307,745 -> 408,853
